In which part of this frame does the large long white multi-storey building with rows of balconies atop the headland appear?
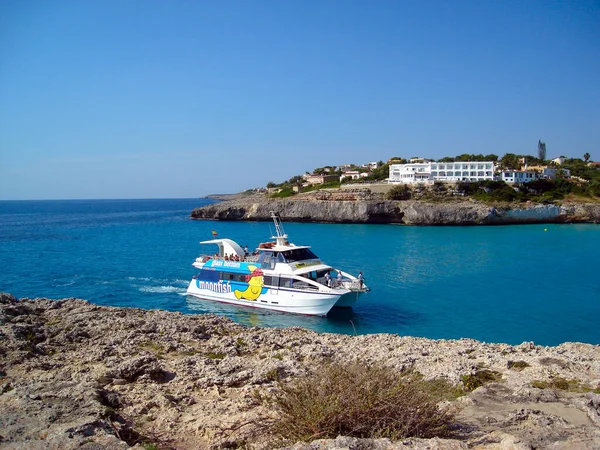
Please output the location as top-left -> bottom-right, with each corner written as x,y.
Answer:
389,161 -> 495,184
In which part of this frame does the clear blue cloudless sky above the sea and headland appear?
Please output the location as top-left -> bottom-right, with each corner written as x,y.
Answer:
0,0 -> 600,199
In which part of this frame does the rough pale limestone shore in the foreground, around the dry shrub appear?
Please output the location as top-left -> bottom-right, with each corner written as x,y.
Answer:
0,294 -> 600,450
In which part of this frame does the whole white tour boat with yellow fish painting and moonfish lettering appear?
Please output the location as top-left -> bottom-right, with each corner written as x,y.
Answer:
187,211 -> 369,316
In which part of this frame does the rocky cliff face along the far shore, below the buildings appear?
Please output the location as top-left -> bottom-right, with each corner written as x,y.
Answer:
191,191 -> 600,225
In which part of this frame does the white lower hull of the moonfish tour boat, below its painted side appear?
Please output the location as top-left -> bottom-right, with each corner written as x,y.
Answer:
187,280 -> 343,316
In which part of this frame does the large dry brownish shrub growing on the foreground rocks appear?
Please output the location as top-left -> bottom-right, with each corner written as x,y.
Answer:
261,363 -> 454,442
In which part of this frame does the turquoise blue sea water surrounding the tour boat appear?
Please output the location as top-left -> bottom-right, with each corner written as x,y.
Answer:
0,199 -> 600,345
